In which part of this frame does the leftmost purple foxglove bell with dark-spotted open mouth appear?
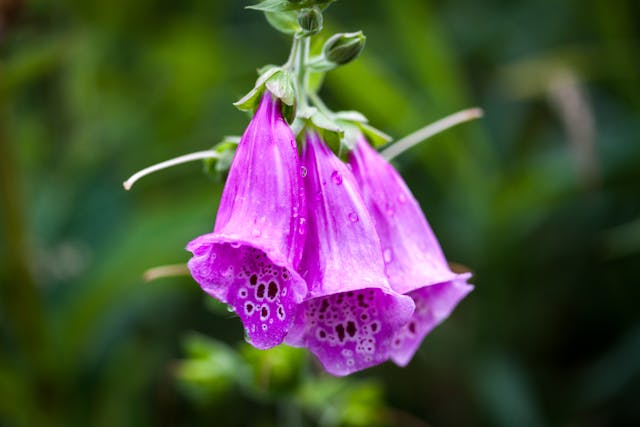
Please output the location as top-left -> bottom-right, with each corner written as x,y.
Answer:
187,92 -> 307,349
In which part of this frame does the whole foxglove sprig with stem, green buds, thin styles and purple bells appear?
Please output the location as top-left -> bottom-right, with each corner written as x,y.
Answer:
124,0 -> 481,375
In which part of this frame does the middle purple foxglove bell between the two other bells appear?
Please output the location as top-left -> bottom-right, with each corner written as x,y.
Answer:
286,133 -> 414,375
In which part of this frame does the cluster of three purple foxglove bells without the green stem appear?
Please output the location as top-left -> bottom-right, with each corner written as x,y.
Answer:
187,90 -> 472,375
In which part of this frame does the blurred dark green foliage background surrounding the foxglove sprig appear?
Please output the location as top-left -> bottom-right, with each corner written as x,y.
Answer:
0,0 -> 640,427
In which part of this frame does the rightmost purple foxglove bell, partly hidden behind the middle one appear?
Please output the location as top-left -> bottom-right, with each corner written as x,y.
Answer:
349,136 -> 473,366
